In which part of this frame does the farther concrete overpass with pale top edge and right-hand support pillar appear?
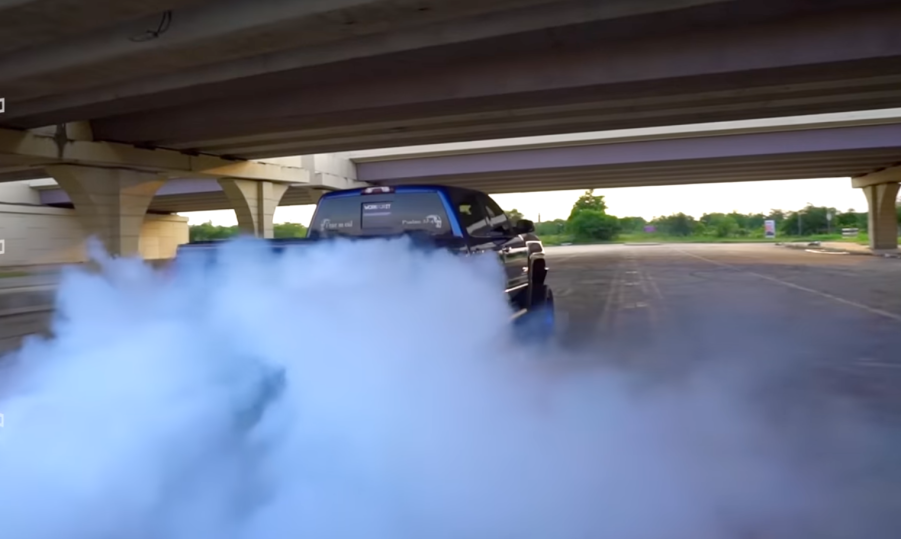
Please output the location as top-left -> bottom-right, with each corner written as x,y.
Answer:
26,113 -> 901,249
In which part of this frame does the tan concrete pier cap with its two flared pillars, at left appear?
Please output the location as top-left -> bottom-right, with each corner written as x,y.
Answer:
0,122 -> 366,255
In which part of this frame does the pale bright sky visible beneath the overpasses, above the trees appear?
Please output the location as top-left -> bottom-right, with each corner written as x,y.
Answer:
181,178 -> 867,226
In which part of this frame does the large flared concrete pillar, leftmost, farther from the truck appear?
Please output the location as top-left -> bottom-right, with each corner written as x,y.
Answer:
47,165 -> 166,256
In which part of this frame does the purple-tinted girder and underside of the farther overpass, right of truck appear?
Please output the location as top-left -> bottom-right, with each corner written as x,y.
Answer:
357,124 -> 901,193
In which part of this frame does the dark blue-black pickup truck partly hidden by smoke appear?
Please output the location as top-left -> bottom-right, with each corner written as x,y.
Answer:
179,185 -> 554,337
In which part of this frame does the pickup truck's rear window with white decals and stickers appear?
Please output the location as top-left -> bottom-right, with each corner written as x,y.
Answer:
310,192 -> 451,236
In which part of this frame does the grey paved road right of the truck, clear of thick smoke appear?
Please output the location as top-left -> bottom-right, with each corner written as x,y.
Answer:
549,244 -> 901,419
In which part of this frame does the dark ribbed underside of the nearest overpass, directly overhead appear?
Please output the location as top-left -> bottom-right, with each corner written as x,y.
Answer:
0,0 -> 901,159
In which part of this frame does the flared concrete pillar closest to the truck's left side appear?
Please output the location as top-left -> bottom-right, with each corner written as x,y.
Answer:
219,178 -> 288,238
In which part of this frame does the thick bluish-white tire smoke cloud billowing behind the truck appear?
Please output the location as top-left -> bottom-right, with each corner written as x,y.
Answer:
0,241 -> 890,539
